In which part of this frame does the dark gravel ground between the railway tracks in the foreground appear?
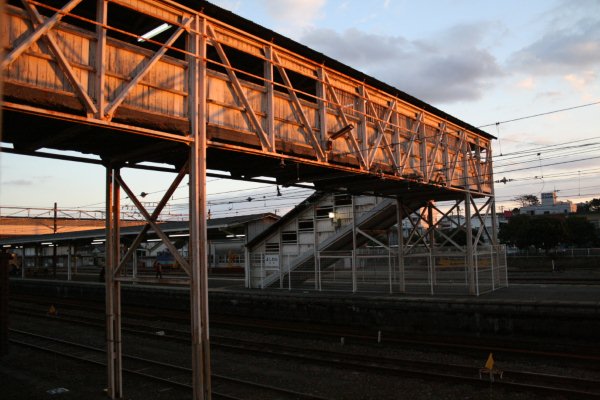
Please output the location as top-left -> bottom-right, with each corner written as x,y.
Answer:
0,306 -> 598,400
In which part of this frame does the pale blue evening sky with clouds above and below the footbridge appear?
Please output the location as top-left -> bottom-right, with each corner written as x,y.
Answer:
0,0 -> 600,217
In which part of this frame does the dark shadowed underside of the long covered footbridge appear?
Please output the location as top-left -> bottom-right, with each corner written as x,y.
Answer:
3,101 -> 474,201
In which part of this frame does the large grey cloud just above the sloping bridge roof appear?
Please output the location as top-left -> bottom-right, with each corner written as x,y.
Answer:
301,24 -> 503,103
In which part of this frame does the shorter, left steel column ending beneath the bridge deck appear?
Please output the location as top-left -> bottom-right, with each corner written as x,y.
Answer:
104,166 -> 123,399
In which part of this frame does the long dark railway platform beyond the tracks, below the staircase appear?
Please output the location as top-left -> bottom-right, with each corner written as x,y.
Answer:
11,278 -> 600,343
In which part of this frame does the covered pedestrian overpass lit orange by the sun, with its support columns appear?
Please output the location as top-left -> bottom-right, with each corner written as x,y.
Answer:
0,0 -> 496,398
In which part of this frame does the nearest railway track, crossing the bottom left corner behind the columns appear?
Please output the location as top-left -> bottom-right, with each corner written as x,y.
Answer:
10,329 -> 329,400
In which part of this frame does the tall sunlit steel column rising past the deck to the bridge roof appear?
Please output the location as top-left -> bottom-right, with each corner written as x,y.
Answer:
188,15 -> 211,400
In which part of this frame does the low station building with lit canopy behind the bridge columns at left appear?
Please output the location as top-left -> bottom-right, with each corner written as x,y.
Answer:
0,213 -> 279,280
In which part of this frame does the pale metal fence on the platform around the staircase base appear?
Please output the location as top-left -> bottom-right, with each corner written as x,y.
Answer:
250,246 -> 508,295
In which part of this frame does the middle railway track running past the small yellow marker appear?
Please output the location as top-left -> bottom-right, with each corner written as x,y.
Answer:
9,304 -> 600,398
